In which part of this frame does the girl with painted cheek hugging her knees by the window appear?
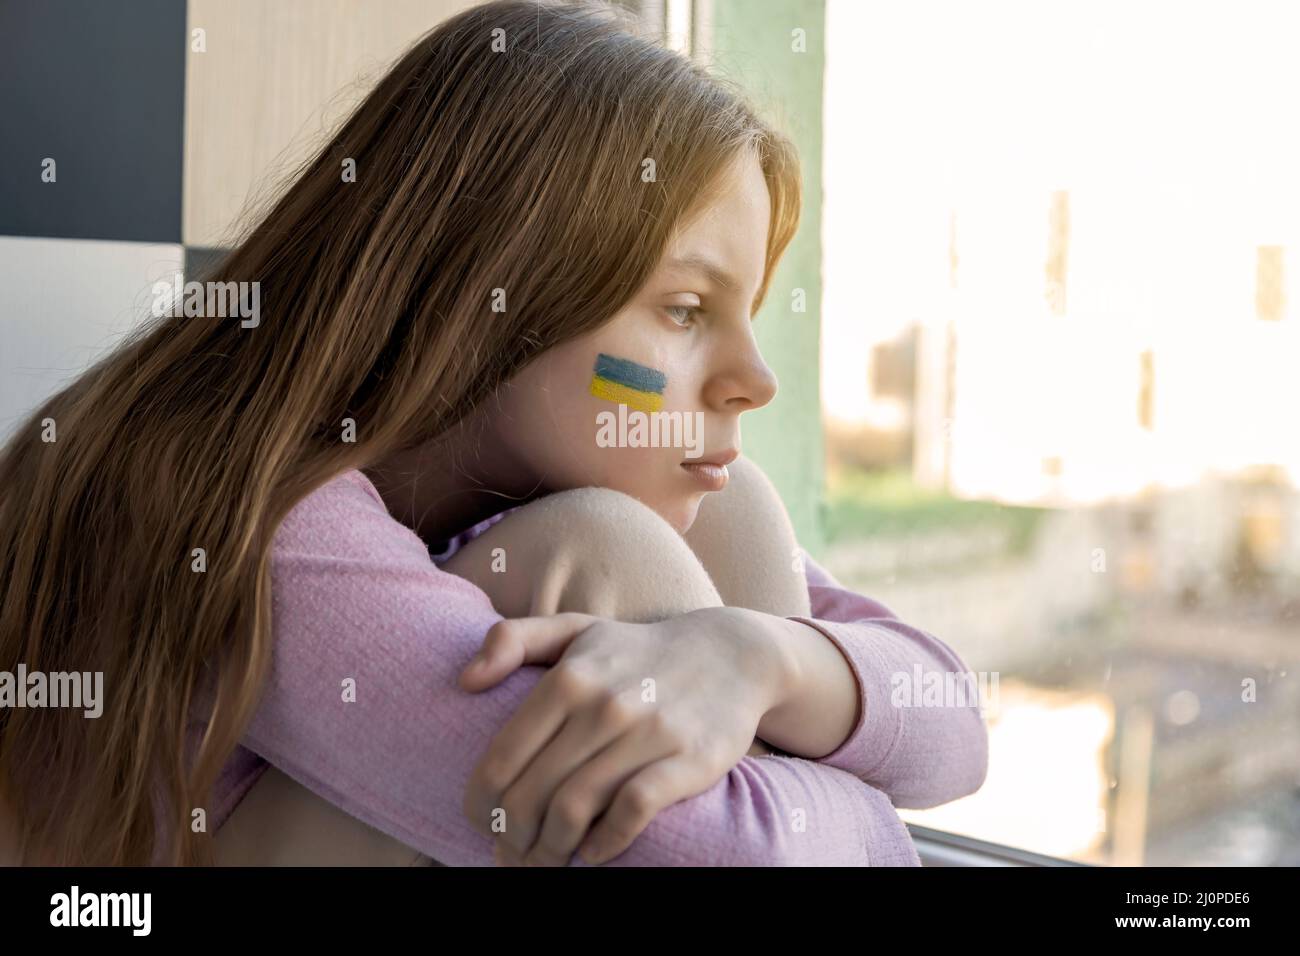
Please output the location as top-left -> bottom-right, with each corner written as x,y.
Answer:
0,0 -> 987,865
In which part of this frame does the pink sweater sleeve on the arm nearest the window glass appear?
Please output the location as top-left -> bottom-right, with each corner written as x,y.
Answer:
790,554 -> 988,809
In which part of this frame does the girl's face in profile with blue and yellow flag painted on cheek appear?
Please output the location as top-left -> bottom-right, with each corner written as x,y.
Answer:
484,155 -> 776,532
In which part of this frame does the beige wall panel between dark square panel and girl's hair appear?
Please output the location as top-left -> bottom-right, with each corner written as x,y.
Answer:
182,0 -> 475,246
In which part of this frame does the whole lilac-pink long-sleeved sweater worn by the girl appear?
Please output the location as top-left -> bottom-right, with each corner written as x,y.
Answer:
199,471 -> 988,866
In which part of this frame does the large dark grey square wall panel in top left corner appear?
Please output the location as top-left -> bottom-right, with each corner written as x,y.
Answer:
0,0 -> 186,242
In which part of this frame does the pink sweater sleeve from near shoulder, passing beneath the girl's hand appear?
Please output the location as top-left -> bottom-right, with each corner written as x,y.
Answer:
243,472 -> 919,866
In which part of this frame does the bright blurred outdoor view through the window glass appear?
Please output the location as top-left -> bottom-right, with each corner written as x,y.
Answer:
820,0 -> 1300,865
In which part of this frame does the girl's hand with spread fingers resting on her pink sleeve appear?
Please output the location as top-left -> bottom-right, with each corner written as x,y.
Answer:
460,607 -> 788,866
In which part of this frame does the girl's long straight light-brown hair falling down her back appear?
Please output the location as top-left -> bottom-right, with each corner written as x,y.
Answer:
0,0 -> 800,865
